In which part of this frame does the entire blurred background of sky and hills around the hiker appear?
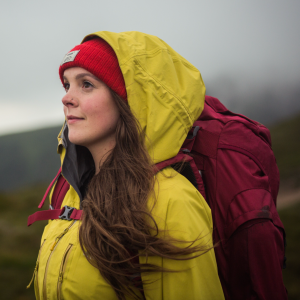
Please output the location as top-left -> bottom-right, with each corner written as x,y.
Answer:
0,0 -> 300,300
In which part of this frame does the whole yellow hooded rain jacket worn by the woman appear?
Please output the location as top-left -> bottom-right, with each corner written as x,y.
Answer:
35,32 -> 224,300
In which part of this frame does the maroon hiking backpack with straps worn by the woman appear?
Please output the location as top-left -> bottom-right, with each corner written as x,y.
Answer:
28,96 -> 287,299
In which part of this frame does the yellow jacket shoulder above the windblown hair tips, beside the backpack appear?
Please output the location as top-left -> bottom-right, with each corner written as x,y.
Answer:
151,167 -> 212,240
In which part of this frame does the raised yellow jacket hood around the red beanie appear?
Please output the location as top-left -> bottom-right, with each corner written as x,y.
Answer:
59,31 -> 205,199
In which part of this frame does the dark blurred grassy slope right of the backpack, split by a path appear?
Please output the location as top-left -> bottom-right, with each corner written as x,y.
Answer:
271,115 -> 300,300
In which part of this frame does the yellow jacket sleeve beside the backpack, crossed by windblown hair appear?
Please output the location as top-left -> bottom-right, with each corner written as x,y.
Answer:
143,170 -> 224,300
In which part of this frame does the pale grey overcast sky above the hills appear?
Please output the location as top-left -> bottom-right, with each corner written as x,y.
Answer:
0,0 -> 300,135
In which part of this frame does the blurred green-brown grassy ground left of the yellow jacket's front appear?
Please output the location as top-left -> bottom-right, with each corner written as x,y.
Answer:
0,185 -> 47,300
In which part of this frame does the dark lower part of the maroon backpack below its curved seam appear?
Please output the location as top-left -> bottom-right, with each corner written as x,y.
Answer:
227,219 -> 287,300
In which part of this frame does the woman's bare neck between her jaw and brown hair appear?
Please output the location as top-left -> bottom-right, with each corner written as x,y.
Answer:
87,137 -> 116,175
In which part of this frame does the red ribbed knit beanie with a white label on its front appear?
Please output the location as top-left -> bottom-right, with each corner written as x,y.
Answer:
59,38 -> 127,101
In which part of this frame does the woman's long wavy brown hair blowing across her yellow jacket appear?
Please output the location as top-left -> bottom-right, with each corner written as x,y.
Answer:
79,91 -> 210,300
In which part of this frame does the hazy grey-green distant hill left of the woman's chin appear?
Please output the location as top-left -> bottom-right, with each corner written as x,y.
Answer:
0,127 -> 60,190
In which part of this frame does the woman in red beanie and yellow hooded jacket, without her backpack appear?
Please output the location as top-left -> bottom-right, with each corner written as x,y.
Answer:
29,32 -> 224,300
